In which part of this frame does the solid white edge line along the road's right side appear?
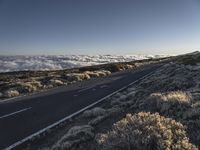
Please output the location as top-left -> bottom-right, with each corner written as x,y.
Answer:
3,67 -> 160,150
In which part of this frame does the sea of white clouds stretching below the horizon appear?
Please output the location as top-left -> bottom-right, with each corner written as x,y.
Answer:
0,55 -> 164,72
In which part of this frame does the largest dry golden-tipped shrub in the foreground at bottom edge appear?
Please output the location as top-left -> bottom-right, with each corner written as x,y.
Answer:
97,112 -> 197,150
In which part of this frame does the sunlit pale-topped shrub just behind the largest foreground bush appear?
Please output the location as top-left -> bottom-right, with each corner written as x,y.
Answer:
142,91 -> 191,118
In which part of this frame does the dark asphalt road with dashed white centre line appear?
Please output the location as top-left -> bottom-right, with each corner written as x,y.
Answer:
0,65 -> 160,149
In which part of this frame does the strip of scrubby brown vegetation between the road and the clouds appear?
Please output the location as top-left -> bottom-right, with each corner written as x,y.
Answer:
0,58 -> 165,99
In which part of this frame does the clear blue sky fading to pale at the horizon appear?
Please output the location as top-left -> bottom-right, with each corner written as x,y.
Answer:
0,0 -> 200,55
